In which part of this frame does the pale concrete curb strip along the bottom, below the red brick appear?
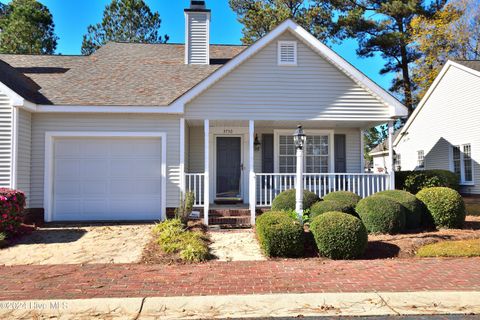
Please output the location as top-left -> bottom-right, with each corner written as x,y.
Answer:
0,291 -> 480,319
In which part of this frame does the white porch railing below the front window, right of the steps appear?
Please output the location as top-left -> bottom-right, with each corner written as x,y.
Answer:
255,173 -> 390,207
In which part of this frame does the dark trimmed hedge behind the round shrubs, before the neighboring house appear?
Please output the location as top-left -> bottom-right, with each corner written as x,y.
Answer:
395,170 -> 460,194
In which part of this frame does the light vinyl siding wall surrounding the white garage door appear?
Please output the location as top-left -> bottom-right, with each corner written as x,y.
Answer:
30,114 -> 180,208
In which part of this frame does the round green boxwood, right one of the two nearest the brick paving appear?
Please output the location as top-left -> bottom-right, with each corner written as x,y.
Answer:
310,212 -> 368,259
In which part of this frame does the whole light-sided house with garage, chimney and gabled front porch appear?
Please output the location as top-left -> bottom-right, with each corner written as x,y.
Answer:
0,1 -> 407,223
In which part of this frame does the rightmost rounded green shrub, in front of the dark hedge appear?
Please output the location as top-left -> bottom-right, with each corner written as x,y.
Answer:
417,187 -> 466,228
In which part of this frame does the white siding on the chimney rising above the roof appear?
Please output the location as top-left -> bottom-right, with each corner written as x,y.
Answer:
186,12 -> 209,64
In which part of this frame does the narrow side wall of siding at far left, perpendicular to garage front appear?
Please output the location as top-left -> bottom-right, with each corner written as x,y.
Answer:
17,109 -> 32,201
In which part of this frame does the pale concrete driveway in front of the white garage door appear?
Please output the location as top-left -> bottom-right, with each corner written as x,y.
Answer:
0,224 -> 153,266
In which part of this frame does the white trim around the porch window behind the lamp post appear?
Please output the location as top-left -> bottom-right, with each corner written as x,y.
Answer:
273,129 -> 334,174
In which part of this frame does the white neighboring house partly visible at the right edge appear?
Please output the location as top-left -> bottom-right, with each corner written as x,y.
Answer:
394,61 -> 480,194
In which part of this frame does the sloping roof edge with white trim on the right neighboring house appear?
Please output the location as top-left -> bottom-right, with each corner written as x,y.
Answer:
393,60 -> 480,146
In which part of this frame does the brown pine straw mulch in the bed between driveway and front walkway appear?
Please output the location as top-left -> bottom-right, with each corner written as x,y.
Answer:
140,220 -> 208,264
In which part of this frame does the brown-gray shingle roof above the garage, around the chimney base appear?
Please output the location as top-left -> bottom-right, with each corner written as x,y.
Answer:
0,42 -> 245,106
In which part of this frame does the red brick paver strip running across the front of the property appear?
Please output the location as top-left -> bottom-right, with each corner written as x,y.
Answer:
0,258 -> 480,300
